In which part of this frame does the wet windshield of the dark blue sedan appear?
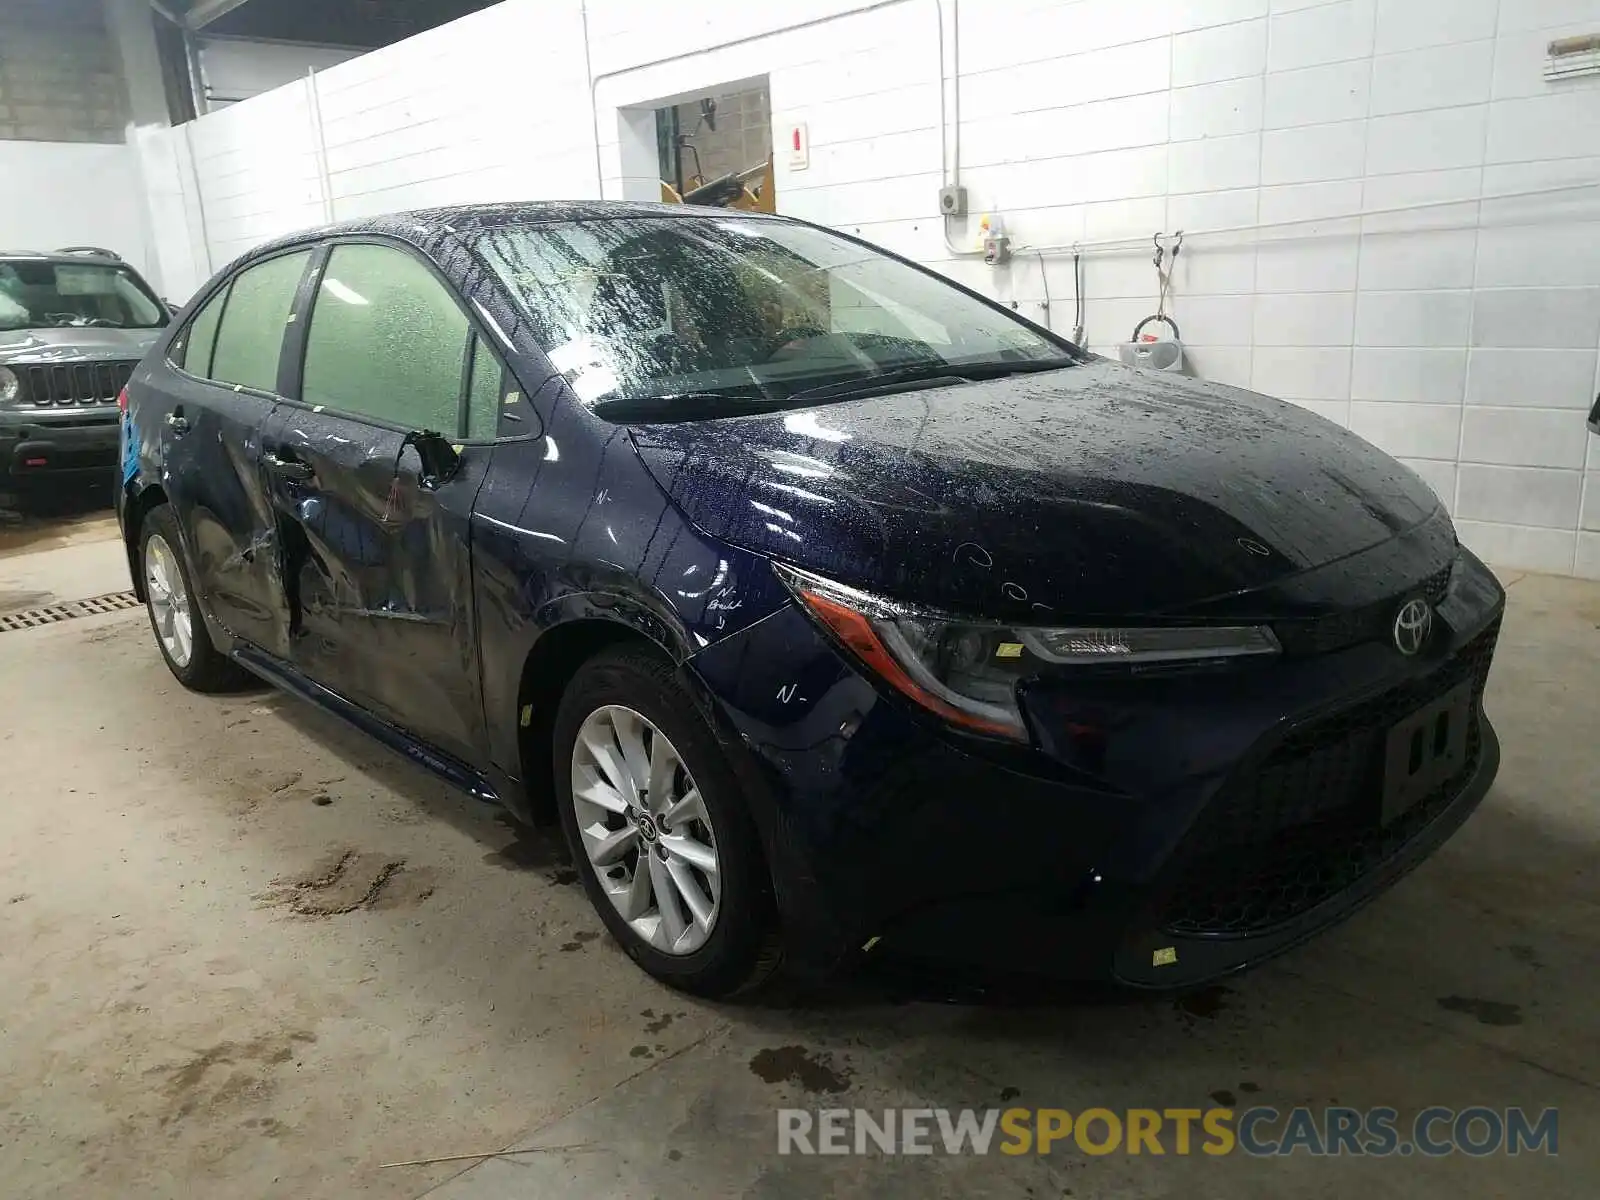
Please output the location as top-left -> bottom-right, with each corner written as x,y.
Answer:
475,216 -> 1074,419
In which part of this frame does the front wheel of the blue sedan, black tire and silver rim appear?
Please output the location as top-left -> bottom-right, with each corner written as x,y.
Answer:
552,646 -> 782,997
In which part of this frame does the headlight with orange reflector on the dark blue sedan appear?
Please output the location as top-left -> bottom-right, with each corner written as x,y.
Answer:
774,563 -> 1282,741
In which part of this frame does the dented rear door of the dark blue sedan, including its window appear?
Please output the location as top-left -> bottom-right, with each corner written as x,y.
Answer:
158,250 -> 312,658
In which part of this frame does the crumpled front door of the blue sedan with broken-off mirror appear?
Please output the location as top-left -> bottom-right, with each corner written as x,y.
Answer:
262,240 -> 504,758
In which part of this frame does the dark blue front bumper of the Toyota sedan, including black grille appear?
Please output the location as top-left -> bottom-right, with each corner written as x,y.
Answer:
691,552 -> 1504,987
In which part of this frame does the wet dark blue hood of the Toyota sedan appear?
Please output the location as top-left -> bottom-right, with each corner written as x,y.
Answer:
632,360 -> 1438,619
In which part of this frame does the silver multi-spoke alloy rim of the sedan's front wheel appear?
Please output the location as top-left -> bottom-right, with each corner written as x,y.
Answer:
573,704 -> 722,955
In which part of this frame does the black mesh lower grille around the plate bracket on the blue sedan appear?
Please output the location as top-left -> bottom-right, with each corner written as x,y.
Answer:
1160,622 -> 1499,936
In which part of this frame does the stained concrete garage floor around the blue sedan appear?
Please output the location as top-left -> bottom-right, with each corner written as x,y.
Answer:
0,492 -> 1600,1200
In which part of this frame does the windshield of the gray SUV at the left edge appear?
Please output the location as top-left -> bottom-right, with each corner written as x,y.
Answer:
0,259 -> 166,330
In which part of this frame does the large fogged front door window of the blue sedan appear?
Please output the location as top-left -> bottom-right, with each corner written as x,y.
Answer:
301,243 -> 469,437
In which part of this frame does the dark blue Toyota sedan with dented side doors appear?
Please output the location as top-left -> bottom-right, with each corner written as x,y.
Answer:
118,203 -> 1504,995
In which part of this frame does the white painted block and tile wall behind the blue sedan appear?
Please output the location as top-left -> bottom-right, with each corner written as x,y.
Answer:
139,0 -> 1600,576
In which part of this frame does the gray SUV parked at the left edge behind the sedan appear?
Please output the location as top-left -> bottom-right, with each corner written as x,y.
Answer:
0,246 -> 170,491
